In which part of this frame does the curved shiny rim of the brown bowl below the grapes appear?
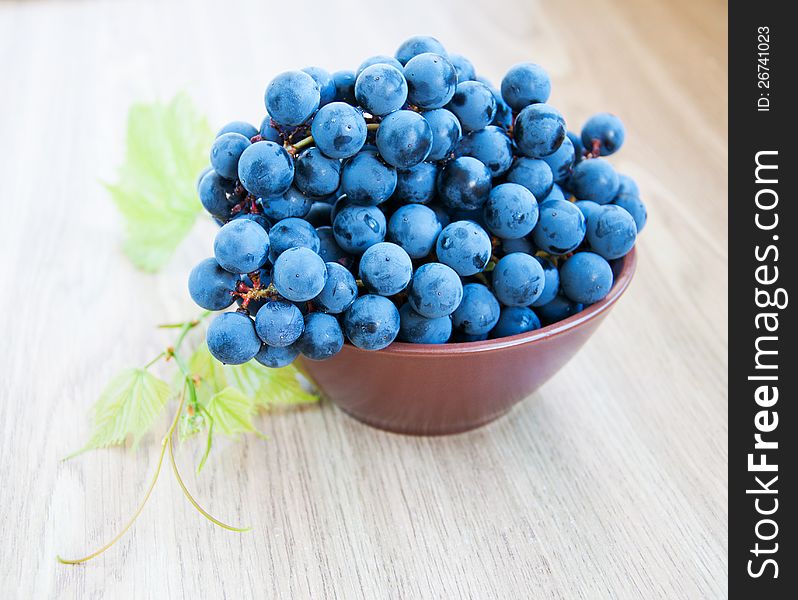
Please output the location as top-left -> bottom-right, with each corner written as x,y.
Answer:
345,247 -> 637,356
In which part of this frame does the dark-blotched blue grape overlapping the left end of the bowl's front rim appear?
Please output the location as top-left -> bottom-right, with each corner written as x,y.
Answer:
344,294 -> 399,350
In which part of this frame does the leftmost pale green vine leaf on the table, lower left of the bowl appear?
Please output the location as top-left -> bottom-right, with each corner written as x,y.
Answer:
67,369 -> 172,458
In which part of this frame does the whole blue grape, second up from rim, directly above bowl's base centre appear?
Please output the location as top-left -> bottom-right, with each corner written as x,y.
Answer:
407,263 -> 463,319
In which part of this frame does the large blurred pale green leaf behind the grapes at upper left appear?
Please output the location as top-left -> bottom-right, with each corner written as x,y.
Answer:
106,93 -> 213,271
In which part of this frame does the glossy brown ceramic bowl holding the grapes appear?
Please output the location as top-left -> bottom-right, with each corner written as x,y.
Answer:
302,250 -> 636,435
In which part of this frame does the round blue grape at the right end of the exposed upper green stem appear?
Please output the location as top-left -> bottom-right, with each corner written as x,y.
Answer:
370,110 -> 432,169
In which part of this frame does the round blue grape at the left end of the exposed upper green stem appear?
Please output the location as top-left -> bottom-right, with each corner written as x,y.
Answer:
238,142 -> 294,198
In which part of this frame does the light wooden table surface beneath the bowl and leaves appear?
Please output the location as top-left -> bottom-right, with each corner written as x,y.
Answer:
0,0 -> 728,600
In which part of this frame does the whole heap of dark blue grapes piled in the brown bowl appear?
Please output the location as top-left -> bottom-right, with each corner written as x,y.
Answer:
188,36 -> 646,367
